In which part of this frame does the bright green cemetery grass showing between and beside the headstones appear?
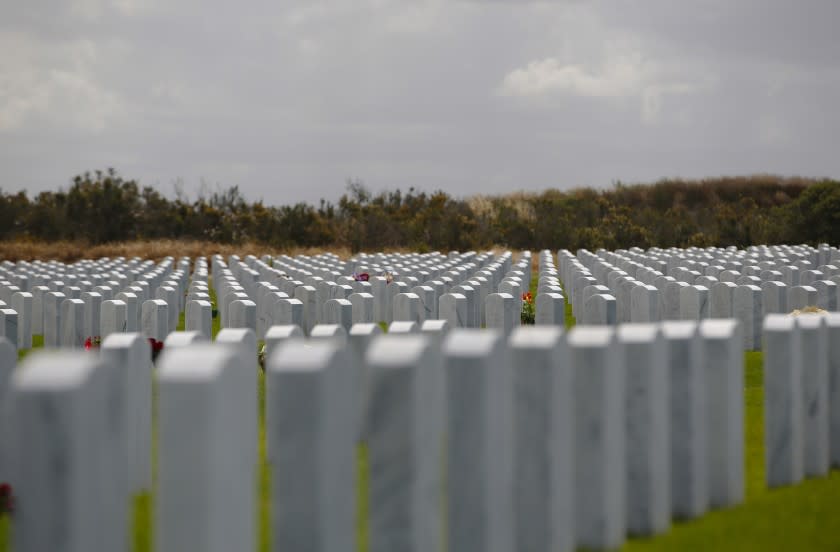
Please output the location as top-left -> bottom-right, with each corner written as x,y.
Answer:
0,270 -> 840,552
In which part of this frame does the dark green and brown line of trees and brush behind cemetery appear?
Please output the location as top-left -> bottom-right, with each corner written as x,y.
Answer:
0,169 -> 840,252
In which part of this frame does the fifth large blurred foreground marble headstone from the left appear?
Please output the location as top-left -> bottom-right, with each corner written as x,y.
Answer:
443,329 -> 514,552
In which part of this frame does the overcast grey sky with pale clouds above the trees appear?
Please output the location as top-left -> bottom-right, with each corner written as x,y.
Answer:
0,0 -> 840,204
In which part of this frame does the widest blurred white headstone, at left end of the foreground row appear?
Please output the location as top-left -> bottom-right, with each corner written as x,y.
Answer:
12,352 -> 122,552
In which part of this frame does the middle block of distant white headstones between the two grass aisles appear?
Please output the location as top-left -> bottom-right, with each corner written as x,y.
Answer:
211,252 -> 540,339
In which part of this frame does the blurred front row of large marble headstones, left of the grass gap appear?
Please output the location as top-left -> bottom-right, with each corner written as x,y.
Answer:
0,320 -> 760,552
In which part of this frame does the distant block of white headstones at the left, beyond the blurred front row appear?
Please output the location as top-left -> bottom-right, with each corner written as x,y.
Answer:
0,258 -> 212,349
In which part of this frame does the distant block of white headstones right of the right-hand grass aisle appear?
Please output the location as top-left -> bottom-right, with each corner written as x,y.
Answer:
557,246 -> 840,349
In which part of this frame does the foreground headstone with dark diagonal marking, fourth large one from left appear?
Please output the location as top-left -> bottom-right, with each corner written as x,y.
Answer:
366,334 -> 445,552
